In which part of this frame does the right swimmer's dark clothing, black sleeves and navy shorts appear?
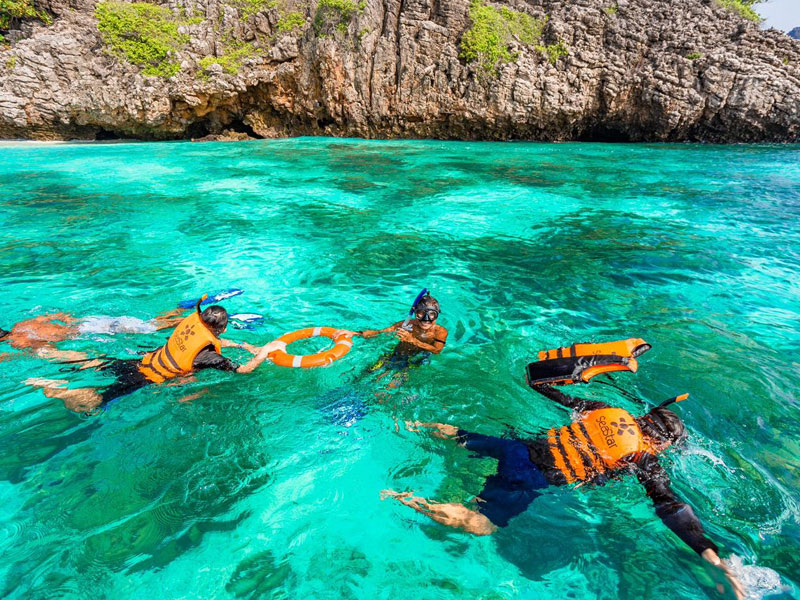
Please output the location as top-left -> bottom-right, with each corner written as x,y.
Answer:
457,386 -> 718,554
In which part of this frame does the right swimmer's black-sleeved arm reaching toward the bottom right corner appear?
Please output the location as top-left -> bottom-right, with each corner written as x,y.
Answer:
635,454 -> 745,600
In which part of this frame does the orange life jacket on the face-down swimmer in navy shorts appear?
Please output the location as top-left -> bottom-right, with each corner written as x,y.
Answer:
547,408 -> 655,483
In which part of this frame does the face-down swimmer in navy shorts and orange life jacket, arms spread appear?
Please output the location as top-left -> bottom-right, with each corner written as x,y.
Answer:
381,385 -> 744,600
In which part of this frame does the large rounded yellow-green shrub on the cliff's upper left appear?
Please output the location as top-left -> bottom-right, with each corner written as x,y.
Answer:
94,1 -> 189,77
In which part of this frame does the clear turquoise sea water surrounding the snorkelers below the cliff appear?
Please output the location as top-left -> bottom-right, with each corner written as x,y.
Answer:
0,139 -> 800,600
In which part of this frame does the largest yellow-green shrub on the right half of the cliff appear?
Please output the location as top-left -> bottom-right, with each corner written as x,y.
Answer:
461,0 -> 569,74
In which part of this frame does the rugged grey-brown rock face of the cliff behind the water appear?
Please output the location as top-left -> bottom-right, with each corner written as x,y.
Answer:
0,0 -> 800,142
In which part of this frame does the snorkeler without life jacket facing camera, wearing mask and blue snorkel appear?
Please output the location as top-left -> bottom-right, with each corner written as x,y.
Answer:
337,291 -> 448,387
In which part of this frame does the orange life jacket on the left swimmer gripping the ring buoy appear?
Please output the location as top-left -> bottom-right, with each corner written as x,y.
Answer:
139,312 -> 220,383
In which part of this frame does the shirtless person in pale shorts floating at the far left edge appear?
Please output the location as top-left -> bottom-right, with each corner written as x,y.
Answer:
0,308 -> 186,361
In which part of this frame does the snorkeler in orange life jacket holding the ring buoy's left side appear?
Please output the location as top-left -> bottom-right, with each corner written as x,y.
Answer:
26,299 -> 284,412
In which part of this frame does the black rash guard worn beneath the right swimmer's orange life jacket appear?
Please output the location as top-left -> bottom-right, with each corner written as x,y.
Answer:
527,385 -> 719,554
